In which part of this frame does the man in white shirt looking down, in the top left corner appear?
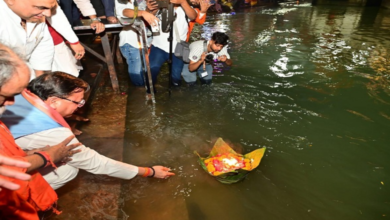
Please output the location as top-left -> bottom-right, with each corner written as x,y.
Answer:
0,0 -> 57,78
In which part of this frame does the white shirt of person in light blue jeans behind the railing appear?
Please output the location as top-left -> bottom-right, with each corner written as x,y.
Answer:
115,0 -> 146,48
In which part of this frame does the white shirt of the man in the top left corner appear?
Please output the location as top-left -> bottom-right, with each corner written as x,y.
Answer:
0,0 -> 54,72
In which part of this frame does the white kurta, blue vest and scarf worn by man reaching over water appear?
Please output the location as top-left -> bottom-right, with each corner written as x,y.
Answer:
1,87 -> 138,189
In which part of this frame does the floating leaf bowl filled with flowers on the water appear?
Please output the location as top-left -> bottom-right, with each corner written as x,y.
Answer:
195,138 -> 266,184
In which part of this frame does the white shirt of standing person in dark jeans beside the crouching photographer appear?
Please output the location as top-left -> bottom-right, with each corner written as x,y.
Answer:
152,6 -> 188,53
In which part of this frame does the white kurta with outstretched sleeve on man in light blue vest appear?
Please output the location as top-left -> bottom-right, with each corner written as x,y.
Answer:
15,127 -> 138,189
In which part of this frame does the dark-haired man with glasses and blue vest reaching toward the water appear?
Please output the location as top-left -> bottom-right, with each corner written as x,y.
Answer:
1,72 -> 174,189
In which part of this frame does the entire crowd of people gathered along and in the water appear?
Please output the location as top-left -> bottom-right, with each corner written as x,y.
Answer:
0,0 -> 232,219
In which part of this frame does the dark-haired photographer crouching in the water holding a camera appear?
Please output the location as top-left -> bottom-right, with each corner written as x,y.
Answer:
182,32 -> 233,86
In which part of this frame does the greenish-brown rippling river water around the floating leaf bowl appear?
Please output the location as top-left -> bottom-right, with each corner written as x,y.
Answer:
120,5 -> 390,220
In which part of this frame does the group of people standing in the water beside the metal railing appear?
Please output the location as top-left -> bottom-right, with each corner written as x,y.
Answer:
115,0 -> 232,92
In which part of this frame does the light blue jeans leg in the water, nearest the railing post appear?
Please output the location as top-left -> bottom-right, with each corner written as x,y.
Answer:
120,44 -> 145,86
